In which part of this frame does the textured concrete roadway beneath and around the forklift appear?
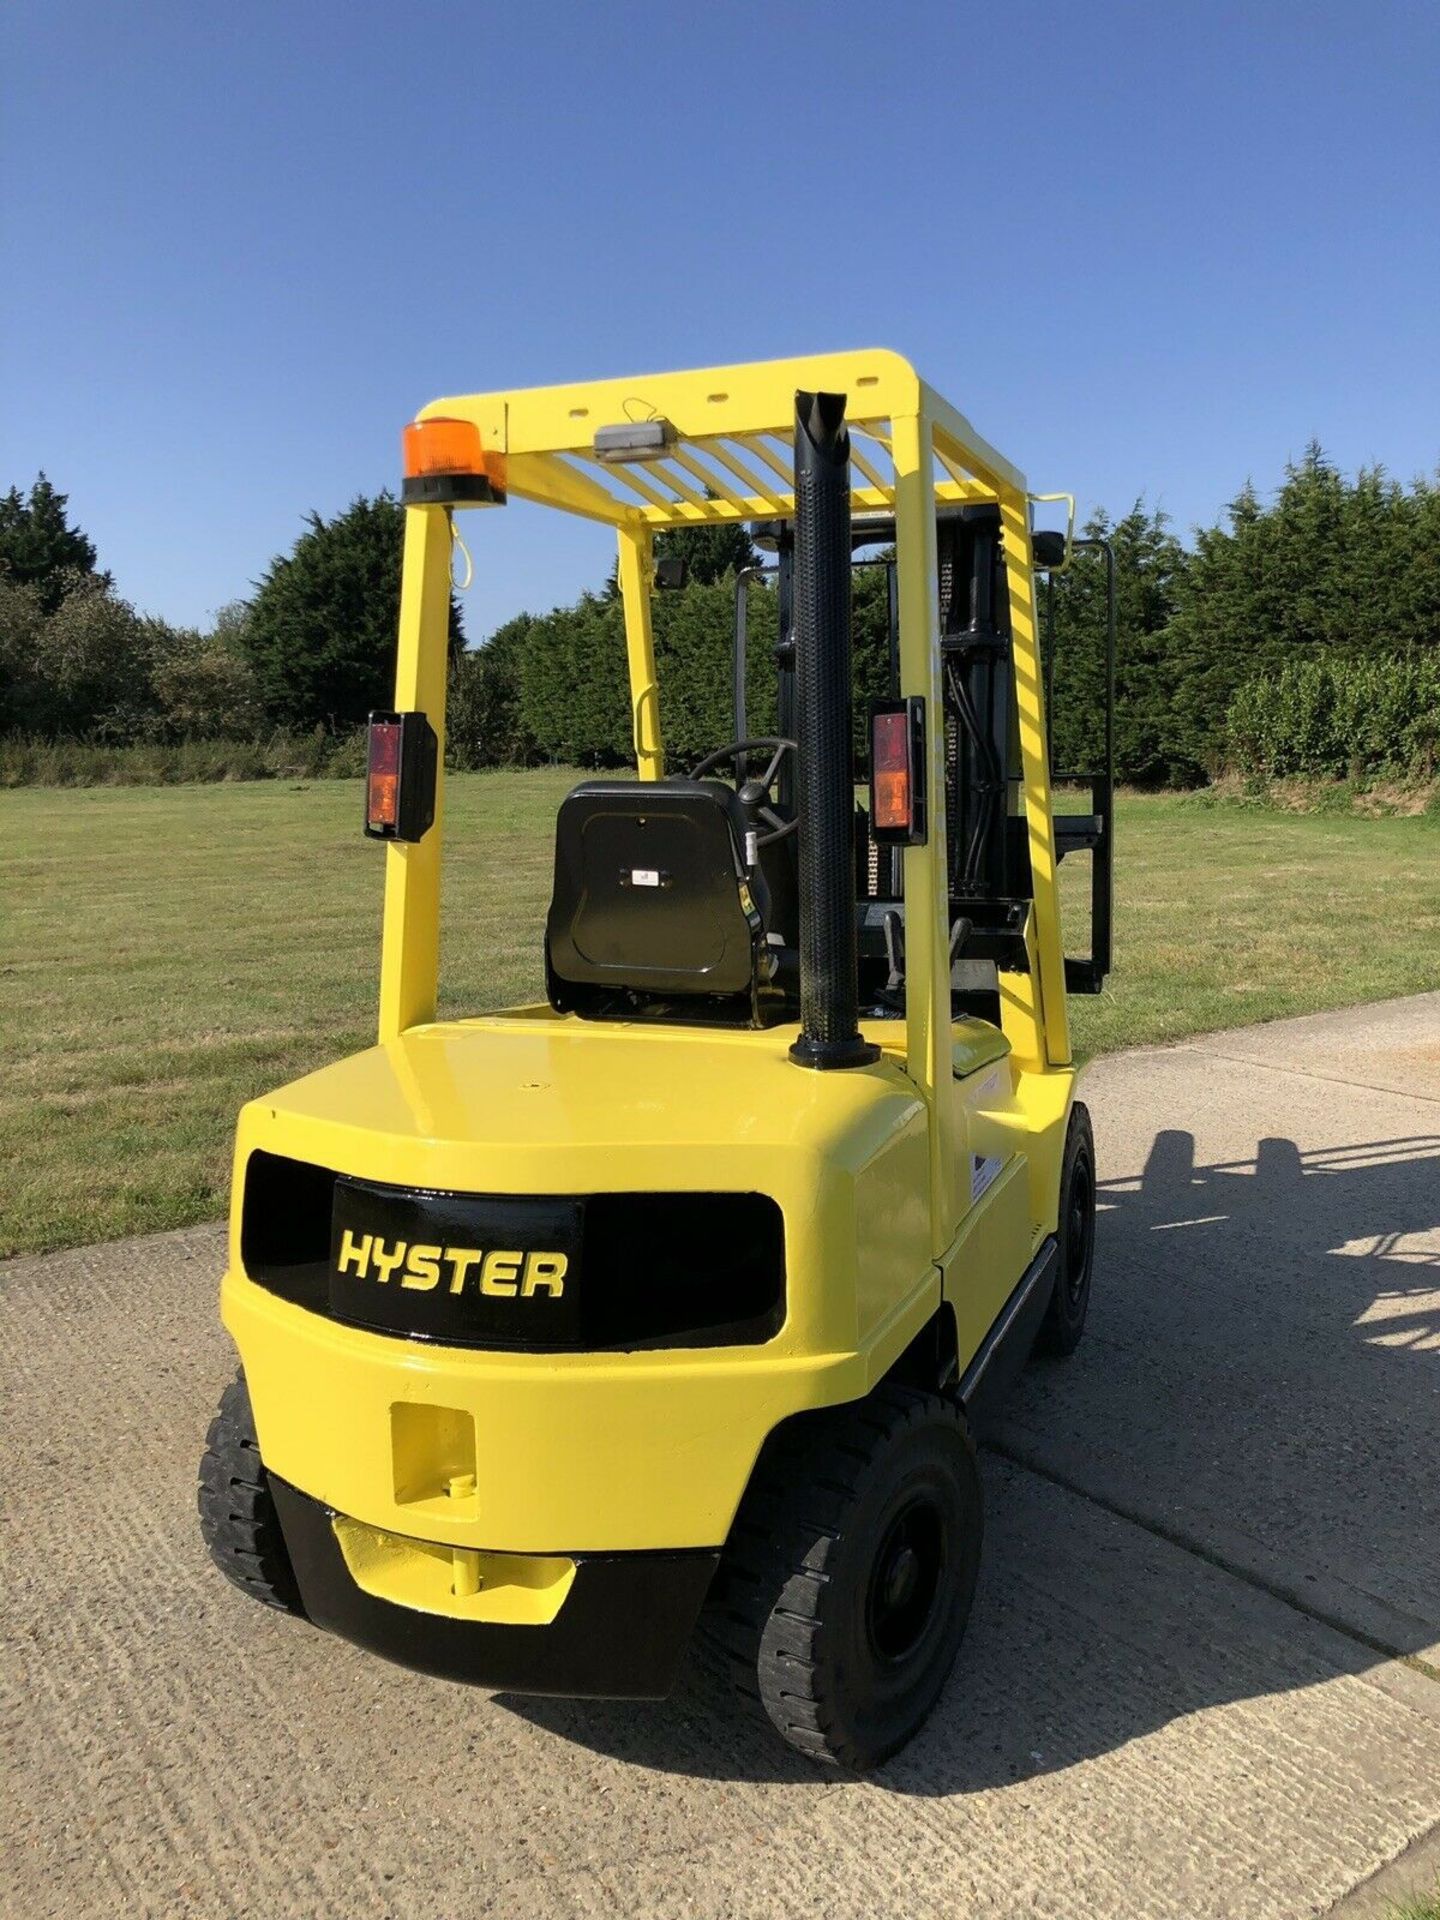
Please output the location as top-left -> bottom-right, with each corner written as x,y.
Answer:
0,995 -> 1440,1920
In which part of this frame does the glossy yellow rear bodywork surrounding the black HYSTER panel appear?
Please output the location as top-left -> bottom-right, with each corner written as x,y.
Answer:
223,1008 -> 1058,1555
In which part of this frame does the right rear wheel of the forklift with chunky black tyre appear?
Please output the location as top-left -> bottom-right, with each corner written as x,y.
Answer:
708,1386 -> 983,1772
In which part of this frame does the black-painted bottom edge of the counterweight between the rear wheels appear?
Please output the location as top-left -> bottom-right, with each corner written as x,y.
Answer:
269,1475 -> 720,1699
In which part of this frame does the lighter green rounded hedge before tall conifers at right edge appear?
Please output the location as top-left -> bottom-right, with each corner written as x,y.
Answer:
1227,649 -> 1440,780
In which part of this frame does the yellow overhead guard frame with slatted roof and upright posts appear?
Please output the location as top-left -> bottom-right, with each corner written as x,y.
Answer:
380,351 -> 1071,1254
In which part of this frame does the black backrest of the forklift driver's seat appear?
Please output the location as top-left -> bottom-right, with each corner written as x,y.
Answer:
545,780 -> 764,1014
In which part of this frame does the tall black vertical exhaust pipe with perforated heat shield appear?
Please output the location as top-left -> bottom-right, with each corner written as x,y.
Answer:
789,394 -> 879,1068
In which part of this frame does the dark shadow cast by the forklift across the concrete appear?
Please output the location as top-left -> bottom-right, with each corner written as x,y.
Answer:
505,1131 -> 1440,1795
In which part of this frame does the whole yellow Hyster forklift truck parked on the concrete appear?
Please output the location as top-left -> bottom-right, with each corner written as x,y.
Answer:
200,351 -> 1110,1766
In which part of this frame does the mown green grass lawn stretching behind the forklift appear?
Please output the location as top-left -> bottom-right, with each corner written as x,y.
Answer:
0,770 -> 1440,1254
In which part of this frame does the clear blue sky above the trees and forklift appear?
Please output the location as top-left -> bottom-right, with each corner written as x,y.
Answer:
0,0 -> 1440,637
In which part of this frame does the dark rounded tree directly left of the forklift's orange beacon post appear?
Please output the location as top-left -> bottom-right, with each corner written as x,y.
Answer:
238,493 -> 463,732
